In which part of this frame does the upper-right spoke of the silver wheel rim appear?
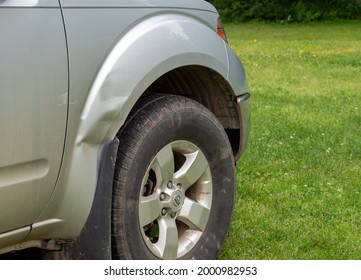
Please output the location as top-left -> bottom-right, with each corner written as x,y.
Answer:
174,150 -> 208,190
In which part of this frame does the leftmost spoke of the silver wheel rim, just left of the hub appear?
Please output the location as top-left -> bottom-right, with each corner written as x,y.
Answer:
139,193 -> 160,227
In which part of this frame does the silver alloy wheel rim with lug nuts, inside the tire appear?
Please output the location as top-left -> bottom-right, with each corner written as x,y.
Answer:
138,141 -> 213,259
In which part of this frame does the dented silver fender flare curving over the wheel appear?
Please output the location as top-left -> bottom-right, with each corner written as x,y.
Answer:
77,14 -> 229,147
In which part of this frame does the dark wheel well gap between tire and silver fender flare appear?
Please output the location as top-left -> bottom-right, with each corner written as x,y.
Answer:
145,66 -> 240,156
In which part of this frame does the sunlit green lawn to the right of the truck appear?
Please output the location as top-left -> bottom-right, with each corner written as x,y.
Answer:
220,21 -> 361,259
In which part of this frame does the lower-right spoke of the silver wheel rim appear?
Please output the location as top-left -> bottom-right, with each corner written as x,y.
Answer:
178,198 -> 210,232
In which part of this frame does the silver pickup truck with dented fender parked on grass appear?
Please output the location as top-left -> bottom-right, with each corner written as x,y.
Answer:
0,0 -> 250,259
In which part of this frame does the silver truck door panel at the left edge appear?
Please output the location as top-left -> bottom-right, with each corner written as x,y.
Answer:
0,0 -> 68,234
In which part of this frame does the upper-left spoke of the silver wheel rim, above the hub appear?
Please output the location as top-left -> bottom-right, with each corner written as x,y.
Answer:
153,145 -> 174,183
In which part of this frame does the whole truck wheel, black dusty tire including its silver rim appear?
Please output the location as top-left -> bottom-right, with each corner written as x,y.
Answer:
112,95 -> 235,259
